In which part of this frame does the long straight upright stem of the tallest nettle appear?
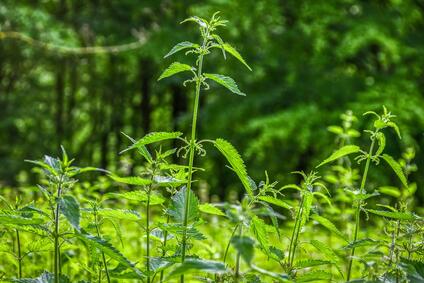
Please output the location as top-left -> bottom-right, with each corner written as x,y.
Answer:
181,34 -> 208,283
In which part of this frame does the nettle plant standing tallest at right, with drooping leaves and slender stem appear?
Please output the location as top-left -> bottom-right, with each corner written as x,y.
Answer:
318,106 -> 408,281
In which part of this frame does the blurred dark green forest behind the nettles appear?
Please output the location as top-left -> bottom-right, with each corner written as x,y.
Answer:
0,0 -> 424,204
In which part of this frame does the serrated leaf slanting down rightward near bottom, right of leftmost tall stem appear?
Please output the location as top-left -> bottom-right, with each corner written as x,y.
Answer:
77,233 -> 141,275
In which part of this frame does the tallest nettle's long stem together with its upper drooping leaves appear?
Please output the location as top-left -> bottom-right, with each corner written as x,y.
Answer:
158,10 -> 250,282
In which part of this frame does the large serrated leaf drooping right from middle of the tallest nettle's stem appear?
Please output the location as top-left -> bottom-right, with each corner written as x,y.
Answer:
214,139 -> 253,197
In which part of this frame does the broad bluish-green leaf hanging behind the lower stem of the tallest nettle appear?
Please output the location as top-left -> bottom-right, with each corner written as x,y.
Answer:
168,187 -> 199,223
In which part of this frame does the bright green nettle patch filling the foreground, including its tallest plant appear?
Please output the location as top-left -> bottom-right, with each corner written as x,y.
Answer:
0,14 -> 424,283
